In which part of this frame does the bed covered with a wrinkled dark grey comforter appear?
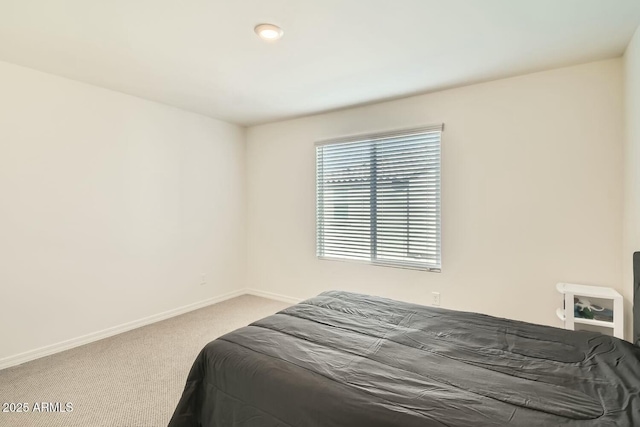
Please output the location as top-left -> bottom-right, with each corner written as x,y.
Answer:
169,291 -> 640,427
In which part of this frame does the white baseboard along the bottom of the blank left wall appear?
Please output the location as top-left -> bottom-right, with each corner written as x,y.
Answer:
0,289 -> 245,369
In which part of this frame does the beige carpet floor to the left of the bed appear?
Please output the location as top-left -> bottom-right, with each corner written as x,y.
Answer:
0,295 -> 289,427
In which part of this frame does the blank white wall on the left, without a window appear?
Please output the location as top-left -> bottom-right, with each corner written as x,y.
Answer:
0,62 -> 246,365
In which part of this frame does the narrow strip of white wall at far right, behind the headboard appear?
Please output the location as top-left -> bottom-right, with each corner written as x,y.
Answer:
623,28 -> 640,339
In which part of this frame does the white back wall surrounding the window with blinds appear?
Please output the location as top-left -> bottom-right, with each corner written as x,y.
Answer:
247,59 -> 623,332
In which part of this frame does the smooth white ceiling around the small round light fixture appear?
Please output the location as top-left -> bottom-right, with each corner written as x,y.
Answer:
0,0 -> 640,125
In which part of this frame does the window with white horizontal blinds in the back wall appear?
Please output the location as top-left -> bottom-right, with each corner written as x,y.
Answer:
316,126 -> 442,271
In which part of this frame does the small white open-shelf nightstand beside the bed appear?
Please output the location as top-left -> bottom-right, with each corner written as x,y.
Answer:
556,283 -> 624,339
